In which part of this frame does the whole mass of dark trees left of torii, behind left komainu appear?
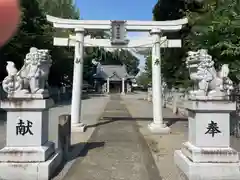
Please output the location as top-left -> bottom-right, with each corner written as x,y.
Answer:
0,0 -> 78,86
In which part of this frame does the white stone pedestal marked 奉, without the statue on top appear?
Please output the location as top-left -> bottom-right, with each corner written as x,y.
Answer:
174,100 -> 240,180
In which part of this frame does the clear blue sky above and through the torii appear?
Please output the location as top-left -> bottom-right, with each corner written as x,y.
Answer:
75,0 -> 157,71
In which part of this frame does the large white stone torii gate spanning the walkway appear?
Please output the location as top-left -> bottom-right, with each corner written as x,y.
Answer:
47,15 -> 188,133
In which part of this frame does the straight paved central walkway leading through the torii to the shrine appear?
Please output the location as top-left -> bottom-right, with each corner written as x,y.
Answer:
64,95 -> 161,180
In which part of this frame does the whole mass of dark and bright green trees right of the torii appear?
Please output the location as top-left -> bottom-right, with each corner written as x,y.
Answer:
153,0 -> 240,86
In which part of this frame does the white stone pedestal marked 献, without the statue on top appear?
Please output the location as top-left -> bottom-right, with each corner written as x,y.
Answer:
0,98 -> 62,180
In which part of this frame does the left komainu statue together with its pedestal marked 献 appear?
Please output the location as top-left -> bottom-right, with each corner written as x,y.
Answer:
0,47 -> 62,180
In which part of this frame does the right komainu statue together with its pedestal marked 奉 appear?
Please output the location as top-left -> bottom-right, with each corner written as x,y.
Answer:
174,49 -> 240,180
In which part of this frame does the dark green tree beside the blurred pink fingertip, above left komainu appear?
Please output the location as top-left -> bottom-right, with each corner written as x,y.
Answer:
0,0 -> 52,79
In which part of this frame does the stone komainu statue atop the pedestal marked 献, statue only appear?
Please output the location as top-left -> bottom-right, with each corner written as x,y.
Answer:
2,47 -> 52,98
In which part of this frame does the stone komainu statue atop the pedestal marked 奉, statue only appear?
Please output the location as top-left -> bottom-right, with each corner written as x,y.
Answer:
186,49 -> 233,99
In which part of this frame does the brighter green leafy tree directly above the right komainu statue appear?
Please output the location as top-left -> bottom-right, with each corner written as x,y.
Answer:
188,0 -> 240,81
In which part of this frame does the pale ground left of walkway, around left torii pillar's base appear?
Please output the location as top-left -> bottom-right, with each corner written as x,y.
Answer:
49,96 -> 109,180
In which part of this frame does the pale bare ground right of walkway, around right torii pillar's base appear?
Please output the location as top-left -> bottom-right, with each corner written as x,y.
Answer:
123,93 -> 188,180
